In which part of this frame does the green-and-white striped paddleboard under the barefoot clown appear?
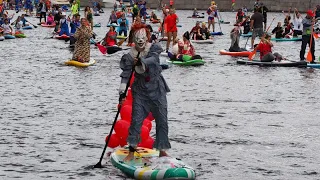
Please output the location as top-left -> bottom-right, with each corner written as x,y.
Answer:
110,147 -> 196,180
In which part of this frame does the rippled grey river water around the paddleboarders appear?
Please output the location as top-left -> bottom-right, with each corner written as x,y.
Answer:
0,9 -> 320,180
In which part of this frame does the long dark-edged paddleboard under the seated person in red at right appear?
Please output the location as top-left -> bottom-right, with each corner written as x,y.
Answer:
237,60 -> 307,67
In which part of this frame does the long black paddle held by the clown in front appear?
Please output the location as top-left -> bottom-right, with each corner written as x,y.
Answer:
93,52 -> 140,168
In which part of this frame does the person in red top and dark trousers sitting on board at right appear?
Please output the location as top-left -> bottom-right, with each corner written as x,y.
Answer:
257,34 -> 284,62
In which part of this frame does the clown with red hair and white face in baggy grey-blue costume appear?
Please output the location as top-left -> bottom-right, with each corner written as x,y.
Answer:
119,24 -> 171,163
